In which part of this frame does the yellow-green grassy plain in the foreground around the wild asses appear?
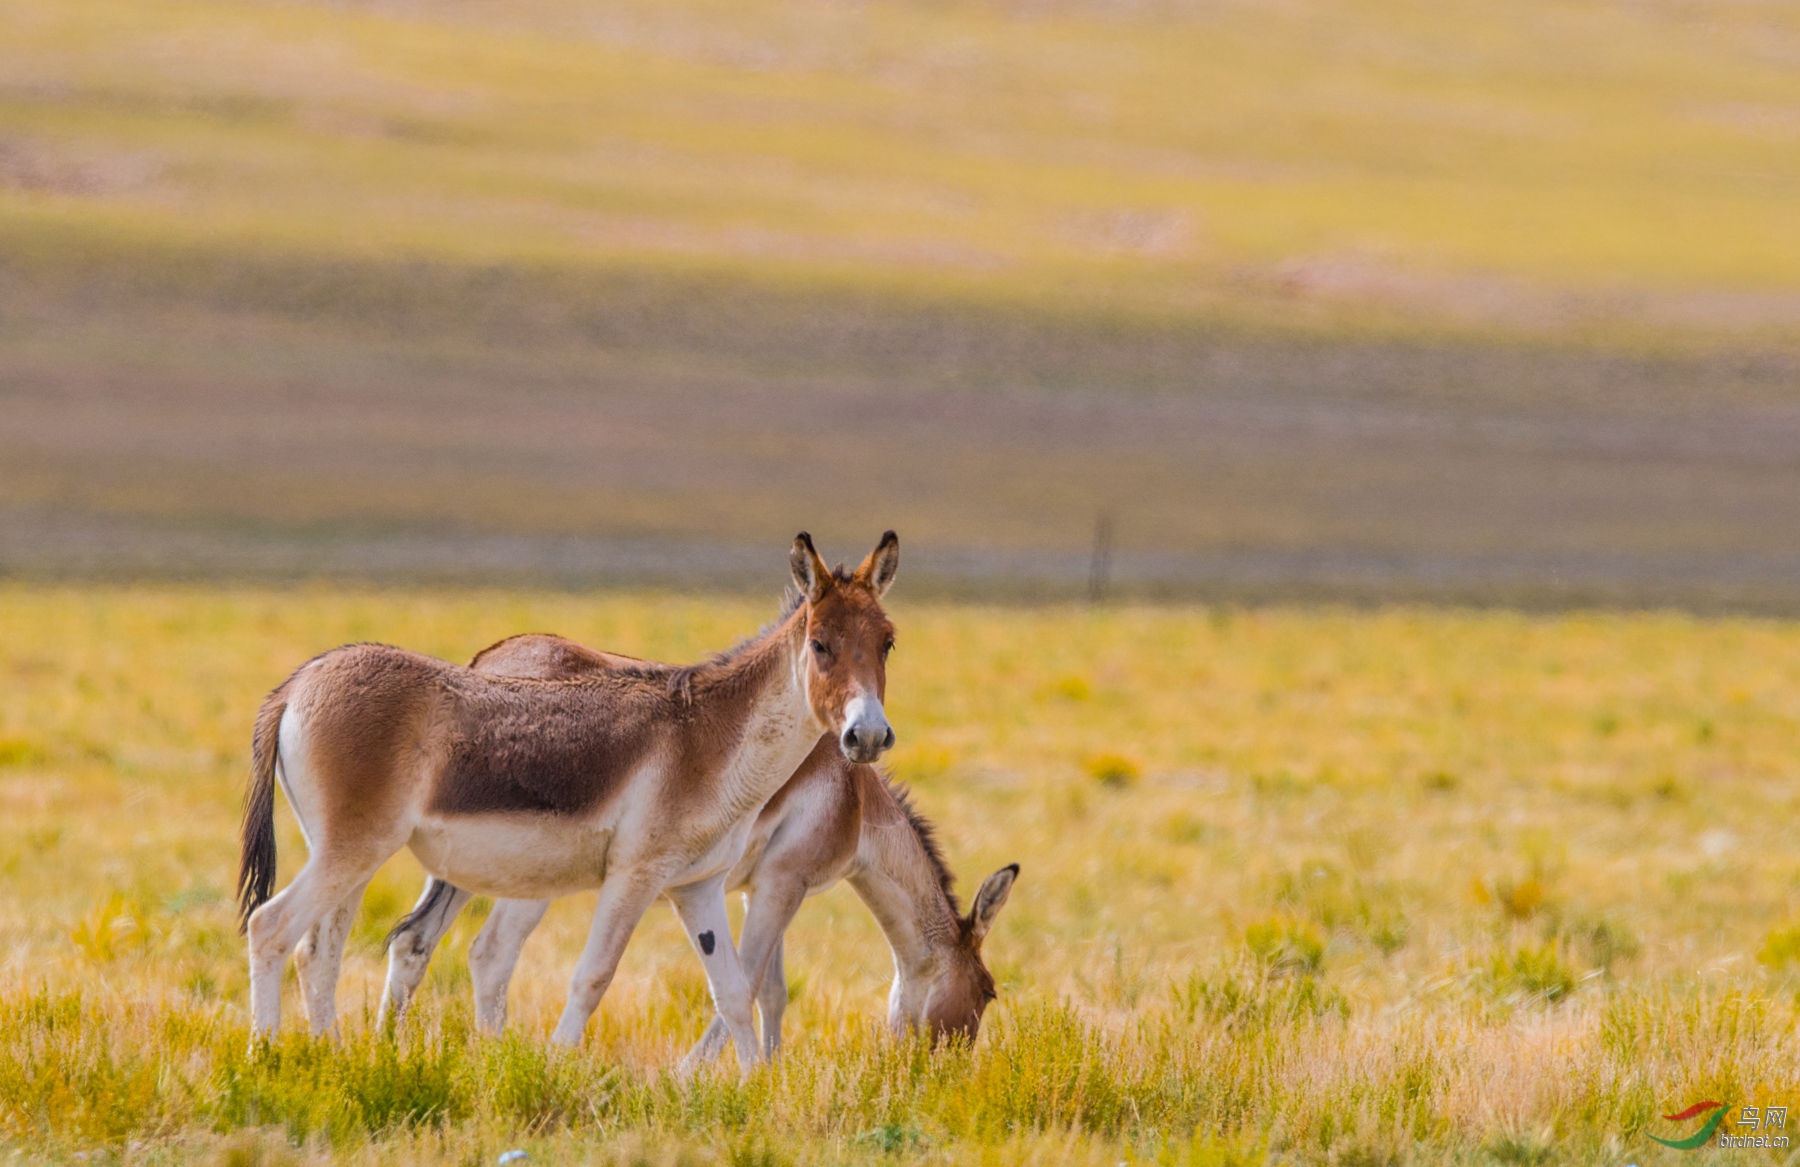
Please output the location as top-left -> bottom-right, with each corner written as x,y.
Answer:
0,585 -> 1800,1165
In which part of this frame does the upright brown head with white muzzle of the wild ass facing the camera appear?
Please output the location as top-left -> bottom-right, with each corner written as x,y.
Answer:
788,531 -> 900,762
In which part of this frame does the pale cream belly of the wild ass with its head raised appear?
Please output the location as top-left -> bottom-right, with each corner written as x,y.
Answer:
409,814 -> 612,899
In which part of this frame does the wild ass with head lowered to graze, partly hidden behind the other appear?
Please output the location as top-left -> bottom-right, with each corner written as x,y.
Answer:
382,634 -> 1019,1063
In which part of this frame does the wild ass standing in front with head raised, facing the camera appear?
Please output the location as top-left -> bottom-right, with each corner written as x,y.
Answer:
238,531 -> 900,1066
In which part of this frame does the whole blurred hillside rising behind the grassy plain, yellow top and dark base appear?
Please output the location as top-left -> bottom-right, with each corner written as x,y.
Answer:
0,0 -> 1800,607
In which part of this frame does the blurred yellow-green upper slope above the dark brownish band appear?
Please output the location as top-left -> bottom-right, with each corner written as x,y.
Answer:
10,0 -> 1800,340
